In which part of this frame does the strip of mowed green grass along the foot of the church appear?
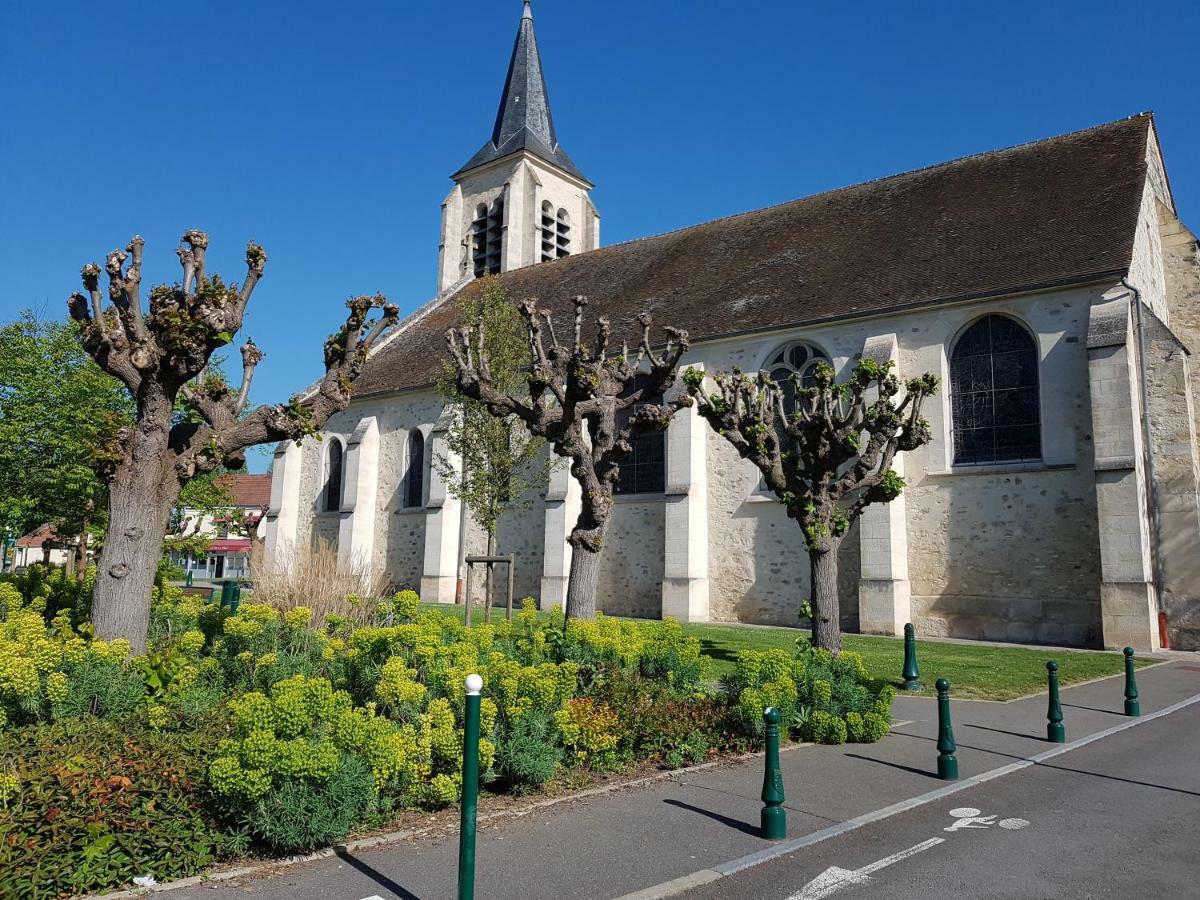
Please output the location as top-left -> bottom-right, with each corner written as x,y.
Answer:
422,604 -> 1153,700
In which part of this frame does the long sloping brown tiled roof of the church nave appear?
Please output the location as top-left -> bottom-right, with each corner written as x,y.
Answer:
356,114 -> 1152,396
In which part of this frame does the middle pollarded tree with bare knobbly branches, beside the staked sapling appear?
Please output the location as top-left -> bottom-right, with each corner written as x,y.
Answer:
446,296 -> 692,619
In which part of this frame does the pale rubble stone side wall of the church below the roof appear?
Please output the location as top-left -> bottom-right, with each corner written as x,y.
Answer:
272,282 -> 1171,646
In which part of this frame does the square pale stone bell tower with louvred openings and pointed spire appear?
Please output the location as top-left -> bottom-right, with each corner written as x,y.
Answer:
438,0 -> 600,296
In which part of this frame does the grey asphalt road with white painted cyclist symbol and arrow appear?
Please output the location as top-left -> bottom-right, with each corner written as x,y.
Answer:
683,704 -> 1200,900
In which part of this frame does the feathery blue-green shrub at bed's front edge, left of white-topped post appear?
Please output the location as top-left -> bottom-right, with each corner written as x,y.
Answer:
246,752 -> 374,853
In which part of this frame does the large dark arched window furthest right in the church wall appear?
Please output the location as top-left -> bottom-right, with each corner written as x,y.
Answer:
950,316 -> 1042,466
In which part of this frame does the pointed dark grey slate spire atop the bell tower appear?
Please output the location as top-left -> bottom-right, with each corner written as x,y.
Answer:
455,0 -> 587,181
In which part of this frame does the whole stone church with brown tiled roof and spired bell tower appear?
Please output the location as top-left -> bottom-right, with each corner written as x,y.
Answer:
266,2 -> 1200,650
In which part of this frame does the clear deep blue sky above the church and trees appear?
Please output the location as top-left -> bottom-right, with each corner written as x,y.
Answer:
0,0 -> 1200,475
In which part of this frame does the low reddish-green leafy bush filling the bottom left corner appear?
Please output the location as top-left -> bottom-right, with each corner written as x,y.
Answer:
0,720 -> 235,898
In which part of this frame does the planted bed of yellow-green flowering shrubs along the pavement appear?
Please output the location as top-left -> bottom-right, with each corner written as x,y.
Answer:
0,582 -> 892,896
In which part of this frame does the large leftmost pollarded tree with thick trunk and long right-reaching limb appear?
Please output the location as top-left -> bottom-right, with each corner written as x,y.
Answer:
67,230 -> 397,653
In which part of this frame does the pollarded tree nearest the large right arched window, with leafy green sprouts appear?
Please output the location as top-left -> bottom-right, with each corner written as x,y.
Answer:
684,359 -> 937,653
